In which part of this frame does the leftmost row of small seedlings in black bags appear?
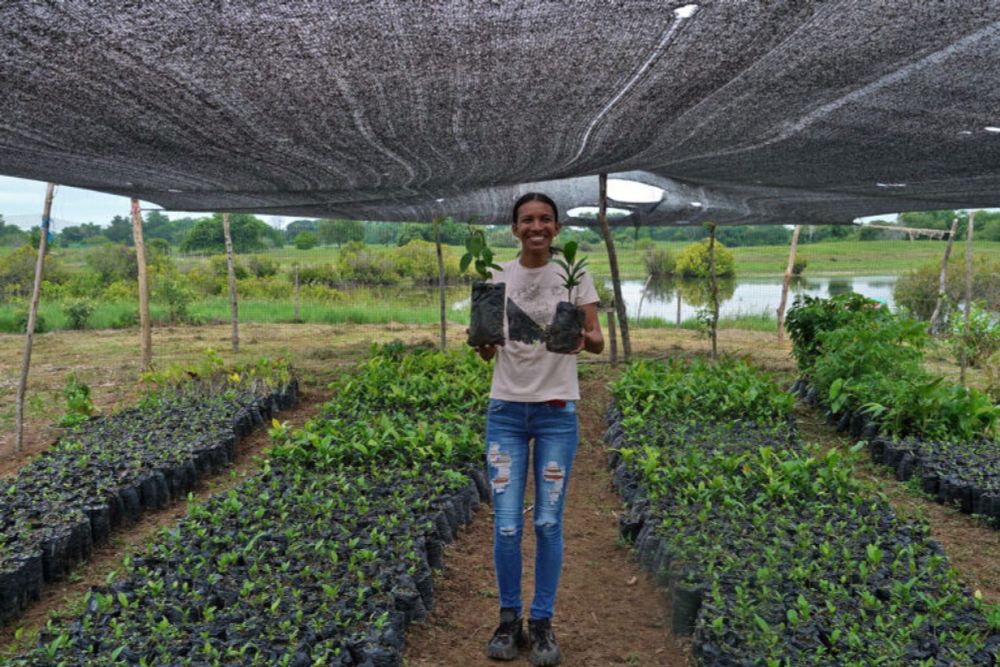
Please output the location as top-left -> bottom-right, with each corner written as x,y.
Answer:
0,361 -> 297,623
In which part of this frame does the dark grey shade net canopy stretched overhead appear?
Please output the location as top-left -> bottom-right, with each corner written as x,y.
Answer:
0,0 -> 1000,225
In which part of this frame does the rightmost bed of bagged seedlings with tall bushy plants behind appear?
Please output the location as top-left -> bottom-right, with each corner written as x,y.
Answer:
789,294 -> 1000,527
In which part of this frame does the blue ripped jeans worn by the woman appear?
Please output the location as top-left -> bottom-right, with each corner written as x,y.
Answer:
486,398 -> 580,619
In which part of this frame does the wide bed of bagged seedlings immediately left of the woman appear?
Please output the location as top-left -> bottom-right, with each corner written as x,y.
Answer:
6,348 -> 488,667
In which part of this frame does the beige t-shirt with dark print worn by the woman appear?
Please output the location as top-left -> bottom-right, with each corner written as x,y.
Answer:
490,259 -> 598,402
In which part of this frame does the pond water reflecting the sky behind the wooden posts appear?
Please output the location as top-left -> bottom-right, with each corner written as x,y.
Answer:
608,276 -> 896,322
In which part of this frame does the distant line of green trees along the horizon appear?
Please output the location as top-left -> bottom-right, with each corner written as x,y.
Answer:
0,211 -> 1000,254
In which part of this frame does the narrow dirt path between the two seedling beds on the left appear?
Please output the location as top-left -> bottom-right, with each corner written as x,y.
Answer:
0,388 -> 330,655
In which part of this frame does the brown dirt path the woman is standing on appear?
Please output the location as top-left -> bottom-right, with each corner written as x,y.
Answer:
404,378 -> 690,667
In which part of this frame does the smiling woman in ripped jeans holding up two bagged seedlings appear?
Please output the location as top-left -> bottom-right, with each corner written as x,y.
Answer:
476,192 -> 604,667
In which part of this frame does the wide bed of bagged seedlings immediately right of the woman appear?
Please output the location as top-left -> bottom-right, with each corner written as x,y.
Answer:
607,362 -> 1000,666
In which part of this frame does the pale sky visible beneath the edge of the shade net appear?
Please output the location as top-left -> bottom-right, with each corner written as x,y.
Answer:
0,176 -> 896,231
